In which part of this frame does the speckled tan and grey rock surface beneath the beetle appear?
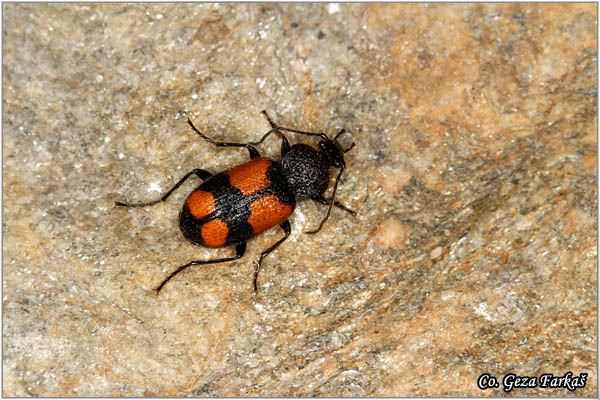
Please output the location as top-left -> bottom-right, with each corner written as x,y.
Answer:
2,4 -> 598,397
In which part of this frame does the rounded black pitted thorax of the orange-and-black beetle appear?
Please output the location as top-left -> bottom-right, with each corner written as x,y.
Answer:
281,144 -> 329,198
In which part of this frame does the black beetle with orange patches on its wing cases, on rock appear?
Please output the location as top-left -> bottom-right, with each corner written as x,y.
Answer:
115,110 -> 356,294
